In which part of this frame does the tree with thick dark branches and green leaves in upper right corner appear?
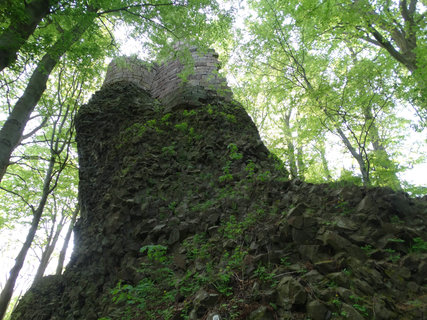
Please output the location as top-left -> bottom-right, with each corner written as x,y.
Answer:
263,0 -> 427,111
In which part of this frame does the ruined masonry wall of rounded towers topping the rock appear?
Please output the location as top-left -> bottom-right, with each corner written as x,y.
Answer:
104,47 -> 231,108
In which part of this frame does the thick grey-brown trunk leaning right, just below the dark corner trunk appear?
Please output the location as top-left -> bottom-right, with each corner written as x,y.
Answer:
0,10 -> 95,182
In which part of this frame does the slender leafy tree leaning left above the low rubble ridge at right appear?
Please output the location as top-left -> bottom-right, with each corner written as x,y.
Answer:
229,0 -> 416,189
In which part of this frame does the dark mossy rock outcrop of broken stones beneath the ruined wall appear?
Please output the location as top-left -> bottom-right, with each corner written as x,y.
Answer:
12,48 -> 427,320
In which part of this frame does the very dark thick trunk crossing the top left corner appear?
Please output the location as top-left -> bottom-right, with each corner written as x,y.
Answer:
0,0 -> 58,71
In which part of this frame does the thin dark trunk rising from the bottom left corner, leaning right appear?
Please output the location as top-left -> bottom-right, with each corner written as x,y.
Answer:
0,157 -> 55,319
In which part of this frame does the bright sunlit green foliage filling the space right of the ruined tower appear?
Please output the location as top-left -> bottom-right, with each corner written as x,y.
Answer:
229,0 -> 425,190
